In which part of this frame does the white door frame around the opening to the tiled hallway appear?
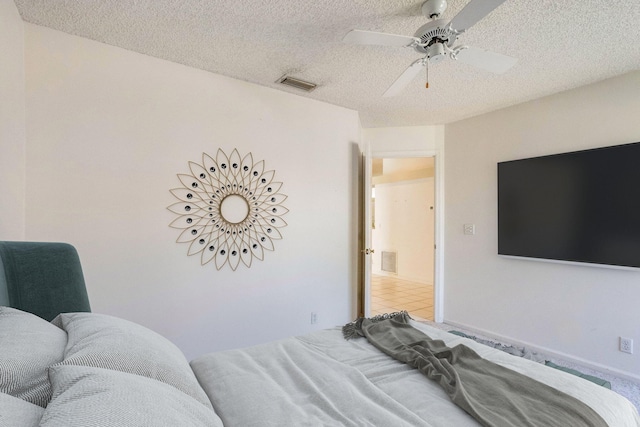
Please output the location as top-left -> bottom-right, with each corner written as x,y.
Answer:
360,149 -> 444,323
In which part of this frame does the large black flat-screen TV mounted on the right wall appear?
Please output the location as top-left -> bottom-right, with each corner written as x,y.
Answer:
498,143 -> 640,267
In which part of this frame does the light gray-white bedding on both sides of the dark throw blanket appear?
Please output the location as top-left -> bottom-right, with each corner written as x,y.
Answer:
191,322 -> 640,427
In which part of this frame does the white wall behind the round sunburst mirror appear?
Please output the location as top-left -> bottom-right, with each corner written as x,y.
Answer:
25,24 -> 360,357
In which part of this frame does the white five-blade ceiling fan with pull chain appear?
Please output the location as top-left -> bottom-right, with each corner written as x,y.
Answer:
343,0 -> 518,97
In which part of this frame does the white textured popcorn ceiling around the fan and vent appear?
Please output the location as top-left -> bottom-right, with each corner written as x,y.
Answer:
15,0 -> 640,128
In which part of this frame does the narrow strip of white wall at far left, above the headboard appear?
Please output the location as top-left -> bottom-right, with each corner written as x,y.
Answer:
0,0 -> 25,240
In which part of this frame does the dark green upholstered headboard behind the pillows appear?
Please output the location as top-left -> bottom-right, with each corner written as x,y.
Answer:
0,241 -> 91,320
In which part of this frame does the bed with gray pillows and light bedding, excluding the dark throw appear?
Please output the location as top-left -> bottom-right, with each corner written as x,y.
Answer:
0,307 -> 640,427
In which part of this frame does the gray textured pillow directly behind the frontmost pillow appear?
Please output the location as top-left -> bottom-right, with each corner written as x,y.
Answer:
52,313 -> 212,408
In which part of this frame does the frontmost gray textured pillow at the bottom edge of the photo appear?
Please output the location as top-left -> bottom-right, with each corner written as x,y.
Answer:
40,365 -> 222,427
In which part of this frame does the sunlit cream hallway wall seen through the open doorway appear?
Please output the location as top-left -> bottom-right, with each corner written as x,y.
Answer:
371,178 -> 435,285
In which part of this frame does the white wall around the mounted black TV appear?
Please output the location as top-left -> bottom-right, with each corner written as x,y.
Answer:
444,72 -> 640,378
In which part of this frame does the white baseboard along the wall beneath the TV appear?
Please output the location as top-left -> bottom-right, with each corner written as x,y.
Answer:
443,319 -> 640,383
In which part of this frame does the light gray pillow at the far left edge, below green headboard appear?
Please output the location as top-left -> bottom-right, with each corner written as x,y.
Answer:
0,307 -> 67,407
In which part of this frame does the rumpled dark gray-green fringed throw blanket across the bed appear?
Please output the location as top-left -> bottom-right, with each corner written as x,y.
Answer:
343,312 -> 607,427
